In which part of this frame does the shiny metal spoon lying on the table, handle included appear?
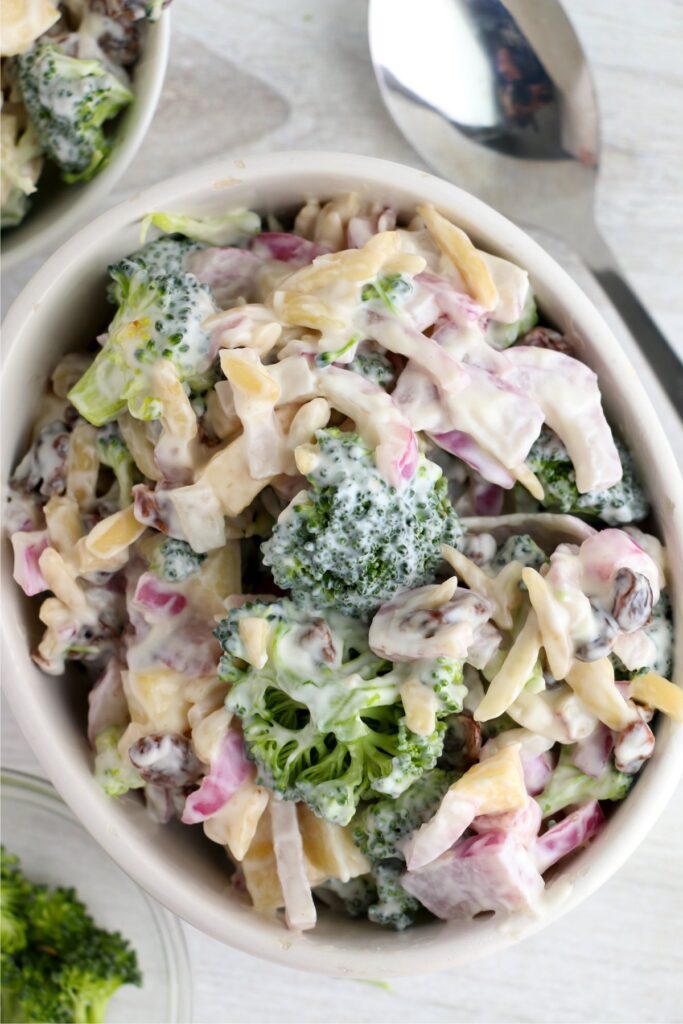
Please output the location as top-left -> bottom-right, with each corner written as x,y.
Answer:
369,0 -> 683,413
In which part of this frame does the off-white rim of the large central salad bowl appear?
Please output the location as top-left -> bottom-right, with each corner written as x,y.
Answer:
2,151 -> 683,978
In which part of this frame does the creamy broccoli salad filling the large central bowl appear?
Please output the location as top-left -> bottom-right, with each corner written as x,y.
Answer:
5,195 -> 683,930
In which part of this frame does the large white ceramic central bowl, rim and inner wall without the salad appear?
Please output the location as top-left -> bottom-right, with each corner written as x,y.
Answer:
2,153 -> 683,978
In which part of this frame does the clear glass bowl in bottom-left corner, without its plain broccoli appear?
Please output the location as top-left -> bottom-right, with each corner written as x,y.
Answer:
0,768 -> 191,1024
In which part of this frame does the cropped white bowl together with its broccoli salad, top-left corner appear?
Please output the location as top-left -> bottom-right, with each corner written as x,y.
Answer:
0,0 -> 168,269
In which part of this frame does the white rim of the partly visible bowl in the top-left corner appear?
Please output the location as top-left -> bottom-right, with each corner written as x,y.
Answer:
2,9 -> 171,273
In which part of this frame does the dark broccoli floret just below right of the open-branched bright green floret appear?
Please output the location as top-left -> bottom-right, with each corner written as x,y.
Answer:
352,768 -> 458,861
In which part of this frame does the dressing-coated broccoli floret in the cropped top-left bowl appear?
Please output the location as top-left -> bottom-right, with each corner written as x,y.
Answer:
17,43 -> 134,182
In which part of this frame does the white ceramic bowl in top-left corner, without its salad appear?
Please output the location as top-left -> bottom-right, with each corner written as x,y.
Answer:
2,17 -> 171,271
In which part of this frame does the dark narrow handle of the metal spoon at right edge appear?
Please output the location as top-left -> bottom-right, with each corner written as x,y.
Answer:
582,227 -> 683,416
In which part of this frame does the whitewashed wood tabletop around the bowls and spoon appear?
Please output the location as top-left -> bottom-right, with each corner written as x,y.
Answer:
2,0 -> 683,1024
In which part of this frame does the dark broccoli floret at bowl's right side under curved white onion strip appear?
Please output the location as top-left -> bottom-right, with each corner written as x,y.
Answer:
526,427 -> 650,526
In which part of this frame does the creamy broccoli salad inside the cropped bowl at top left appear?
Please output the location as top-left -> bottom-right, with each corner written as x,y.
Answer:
0,0 -> 170,227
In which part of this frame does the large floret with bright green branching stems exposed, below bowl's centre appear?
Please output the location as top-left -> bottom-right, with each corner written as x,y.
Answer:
216,600 -> 444,824
